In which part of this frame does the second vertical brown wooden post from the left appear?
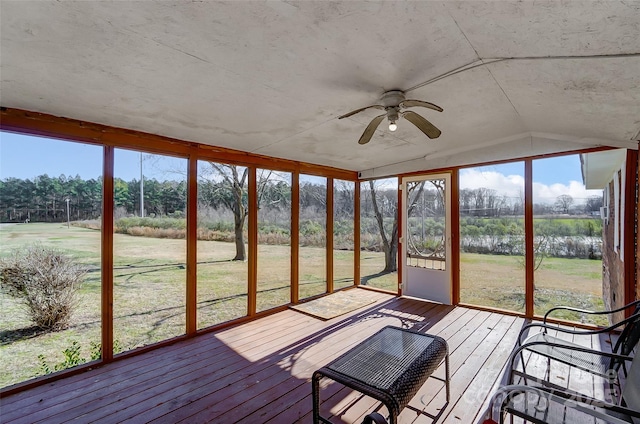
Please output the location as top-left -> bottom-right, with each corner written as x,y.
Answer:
186,155 -> 198,336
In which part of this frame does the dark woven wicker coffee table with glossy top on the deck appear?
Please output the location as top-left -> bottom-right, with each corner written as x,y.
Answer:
312,326 -> 450,424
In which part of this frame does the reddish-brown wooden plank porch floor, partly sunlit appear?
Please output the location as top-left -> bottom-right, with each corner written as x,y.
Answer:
0,290 -> 620,424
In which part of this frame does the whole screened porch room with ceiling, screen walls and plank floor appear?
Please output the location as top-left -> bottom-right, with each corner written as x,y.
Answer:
0,1 -> 640,423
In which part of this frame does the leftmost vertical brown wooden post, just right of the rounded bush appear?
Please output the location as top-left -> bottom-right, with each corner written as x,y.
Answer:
100,146 -> 115,362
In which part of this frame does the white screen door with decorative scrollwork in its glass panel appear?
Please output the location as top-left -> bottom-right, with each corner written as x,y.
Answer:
401,174 -> 452,304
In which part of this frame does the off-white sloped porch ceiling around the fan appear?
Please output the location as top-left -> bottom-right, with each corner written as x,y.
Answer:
0,0 -> 640,177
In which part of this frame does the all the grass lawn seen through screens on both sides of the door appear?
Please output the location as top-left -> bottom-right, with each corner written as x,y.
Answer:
0,223 -> 601,387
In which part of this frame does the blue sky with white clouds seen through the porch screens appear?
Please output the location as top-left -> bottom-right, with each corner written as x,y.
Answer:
0,132 -> 601,202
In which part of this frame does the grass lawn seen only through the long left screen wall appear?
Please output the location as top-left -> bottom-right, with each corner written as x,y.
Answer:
0,223 -> 383,387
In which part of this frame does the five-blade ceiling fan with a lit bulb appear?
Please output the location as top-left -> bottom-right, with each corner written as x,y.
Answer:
338,90 -> 442,144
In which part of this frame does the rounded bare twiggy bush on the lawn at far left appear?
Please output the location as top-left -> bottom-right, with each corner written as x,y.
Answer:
0,245 -> 86,331
